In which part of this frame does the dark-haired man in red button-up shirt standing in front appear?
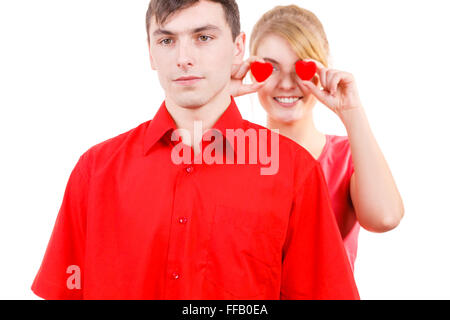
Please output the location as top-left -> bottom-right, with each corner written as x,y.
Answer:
32,0 -> 359,299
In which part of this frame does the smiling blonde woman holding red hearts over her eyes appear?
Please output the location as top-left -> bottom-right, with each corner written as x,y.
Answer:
231,5 -> 404,269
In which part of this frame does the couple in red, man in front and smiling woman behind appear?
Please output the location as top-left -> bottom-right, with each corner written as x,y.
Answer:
32,0 -> 403,300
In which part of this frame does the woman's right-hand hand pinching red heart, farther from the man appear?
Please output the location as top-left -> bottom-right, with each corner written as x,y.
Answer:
297,59 -> 362,119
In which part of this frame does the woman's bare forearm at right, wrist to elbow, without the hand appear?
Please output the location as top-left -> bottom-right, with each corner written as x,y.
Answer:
340,107 -> 404,232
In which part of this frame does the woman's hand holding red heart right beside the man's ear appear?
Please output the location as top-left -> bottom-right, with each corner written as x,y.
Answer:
230,56 -> 267,97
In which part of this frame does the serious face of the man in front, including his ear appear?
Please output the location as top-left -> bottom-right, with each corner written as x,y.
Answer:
149,1 -> 244,108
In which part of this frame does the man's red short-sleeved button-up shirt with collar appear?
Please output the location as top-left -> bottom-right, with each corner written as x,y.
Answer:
32,98 -> 359,299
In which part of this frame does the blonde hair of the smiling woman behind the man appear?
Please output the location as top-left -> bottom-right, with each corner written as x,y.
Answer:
250,5 -> 329,68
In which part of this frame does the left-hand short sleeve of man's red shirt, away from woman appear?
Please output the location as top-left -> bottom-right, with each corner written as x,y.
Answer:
31,155 -> 88,300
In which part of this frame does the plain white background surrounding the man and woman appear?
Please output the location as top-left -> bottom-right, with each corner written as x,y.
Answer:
0,0 -> 450,299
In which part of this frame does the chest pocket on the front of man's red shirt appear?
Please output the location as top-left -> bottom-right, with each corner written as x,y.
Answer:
205,205 -> 282,299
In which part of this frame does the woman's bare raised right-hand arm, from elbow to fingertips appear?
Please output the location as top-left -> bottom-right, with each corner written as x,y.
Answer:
297,59 -> 404,232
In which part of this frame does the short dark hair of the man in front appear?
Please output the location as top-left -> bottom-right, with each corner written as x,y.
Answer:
146,0 -> 241,42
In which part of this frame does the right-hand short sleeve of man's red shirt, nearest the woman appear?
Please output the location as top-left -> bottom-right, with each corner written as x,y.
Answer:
280,158 -> 359,300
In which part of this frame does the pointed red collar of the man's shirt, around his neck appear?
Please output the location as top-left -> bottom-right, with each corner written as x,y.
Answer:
144,96 -> 243,155
